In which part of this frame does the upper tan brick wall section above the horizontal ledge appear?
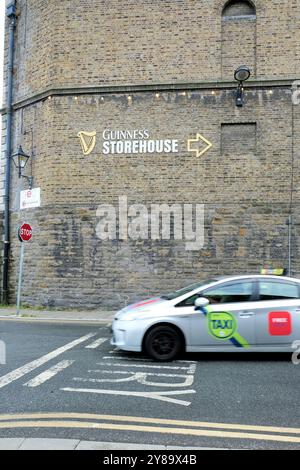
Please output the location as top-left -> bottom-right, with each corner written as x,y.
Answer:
1,0 -> 300,105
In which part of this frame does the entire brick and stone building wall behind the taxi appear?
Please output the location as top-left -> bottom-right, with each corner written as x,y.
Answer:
2,0 -> 300,308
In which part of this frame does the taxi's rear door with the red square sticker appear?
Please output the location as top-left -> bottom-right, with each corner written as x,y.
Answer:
255,278 -> 300,349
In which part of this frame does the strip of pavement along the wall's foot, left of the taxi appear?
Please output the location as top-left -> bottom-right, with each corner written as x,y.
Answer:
0,306 -> 116,324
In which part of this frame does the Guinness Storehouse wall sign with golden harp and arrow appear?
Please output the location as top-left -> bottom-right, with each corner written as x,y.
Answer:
77,129 -> 212,157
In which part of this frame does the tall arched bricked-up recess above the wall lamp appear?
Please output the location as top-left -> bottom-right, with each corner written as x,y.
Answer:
222,0 -> 256,79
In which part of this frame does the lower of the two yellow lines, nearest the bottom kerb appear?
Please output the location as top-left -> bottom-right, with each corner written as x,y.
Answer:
0,421 -> 300,443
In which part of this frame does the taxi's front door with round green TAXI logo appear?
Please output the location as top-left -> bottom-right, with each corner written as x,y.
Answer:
177,278 -> 255,350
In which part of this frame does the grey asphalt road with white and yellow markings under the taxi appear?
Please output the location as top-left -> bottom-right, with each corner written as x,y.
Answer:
0,321 -> 300,449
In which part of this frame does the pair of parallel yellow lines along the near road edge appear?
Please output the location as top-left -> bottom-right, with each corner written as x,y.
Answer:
0,413 -> 300,443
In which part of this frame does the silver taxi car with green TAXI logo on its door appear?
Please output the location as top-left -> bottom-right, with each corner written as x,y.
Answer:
111,275 -> 300,361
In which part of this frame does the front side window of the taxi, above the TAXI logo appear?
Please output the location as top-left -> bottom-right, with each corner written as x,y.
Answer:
202,281 -> 253,304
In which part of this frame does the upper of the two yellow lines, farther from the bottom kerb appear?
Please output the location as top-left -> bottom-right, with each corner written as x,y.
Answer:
0,413 -> 300,434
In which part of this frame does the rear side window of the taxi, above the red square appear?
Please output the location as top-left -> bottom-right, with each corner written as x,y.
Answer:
259,280 -> 299,300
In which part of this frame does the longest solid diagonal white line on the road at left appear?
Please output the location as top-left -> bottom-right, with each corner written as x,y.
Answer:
0,333 -> 96,388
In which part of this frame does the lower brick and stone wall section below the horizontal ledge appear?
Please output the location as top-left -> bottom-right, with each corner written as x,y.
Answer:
5,89 -> 300,307
